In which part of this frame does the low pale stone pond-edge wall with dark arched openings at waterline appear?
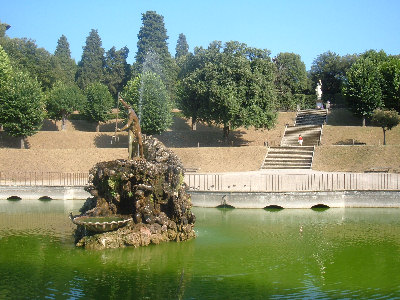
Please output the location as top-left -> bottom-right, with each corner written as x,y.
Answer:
0,186 -> 400,208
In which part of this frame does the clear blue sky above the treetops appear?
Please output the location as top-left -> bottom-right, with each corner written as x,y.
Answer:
0,0 -> 400,70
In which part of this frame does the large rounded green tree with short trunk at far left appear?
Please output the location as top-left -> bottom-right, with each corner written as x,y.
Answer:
0,71 -> 44,148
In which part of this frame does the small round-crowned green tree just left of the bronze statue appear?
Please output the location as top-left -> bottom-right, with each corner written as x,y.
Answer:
84,82 -> 114,132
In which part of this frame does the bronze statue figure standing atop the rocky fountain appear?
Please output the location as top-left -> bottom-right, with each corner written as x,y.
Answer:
118,97 -> 144,159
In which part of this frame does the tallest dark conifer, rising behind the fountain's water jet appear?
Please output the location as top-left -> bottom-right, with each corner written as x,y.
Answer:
133,11 -> 178,99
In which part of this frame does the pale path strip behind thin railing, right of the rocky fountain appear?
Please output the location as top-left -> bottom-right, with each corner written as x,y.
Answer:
185,170 -> 400,192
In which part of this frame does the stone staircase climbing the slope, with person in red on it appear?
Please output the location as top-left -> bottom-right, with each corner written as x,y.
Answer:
261,109 -> 327,169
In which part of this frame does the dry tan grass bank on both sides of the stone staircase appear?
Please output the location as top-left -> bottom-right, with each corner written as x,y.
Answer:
0,110 -> 400,172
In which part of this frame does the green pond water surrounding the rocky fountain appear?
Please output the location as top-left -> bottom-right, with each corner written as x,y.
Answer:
0,200 -> 400,299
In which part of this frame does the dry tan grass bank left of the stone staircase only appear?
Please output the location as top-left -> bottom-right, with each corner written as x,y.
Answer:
0,113 -> 295,172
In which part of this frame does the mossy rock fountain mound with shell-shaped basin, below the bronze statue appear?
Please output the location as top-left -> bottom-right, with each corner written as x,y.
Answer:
70,104 -> 195,249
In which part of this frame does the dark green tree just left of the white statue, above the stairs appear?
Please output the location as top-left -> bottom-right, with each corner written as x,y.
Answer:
273,53 -> 307,110
